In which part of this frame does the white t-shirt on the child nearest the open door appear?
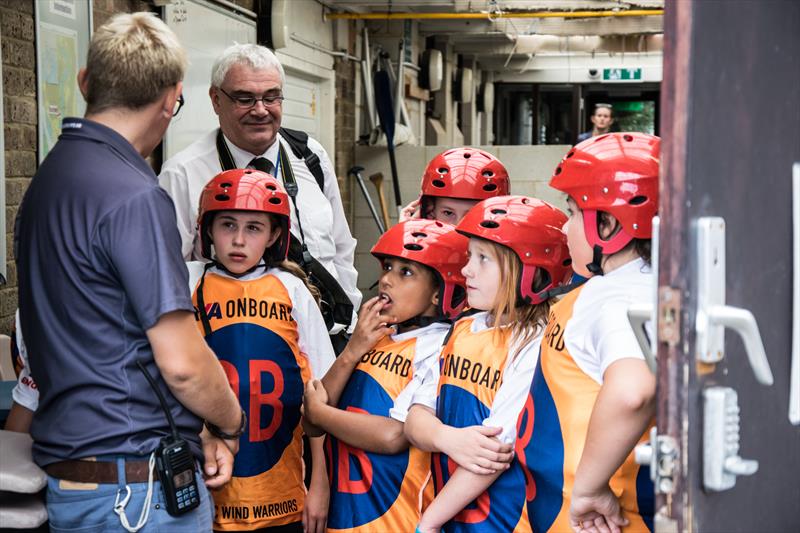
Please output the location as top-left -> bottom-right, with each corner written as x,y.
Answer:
564,259 -> 654,384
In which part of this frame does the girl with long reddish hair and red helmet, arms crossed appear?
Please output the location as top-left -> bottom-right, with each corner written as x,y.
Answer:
406,196 -> 572,533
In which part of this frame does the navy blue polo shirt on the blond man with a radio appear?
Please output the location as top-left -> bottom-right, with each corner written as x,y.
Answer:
16,118 -> 201,466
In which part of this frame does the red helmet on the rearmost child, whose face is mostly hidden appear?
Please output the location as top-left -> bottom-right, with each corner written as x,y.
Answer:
421,148 -> 509,214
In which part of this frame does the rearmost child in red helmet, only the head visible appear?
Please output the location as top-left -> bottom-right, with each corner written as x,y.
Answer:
400,148 -> 509,224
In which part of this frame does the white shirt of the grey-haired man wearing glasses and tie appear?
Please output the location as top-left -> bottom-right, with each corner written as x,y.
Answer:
158,130 -> 361,333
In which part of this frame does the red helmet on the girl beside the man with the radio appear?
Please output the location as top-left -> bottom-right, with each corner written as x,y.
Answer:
197,168 -> 290,264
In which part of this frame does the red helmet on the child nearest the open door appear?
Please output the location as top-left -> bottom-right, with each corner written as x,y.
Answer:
550,133 -> 661,255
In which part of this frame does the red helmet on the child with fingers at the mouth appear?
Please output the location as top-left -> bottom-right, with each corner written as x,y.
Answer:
372,218 -> 469,318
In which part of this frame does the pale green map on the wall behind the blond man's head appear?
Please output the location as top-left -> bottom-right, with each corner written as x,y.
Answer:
39,22 -> 79,154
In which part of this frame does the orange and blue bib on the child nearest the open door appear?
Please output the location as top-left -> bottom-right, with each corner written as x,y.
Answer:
516,287 -> 654,533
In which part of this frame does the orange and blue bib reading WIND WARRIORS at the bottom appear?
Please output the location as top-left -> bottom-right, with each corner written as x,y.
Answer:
192,272 -> 311,530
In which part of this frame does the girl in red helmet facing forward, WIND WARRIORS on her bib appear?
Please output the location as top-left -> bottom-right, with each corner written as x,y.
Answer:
188,169 -> 334,533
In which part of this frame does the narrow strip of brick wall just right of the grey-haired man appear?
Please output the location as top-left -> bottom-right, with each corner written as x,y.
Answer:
333,23 -> 357,218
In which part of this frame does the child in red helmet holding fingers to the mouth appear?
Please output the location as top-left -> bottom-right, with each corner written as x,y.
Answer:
305,220 -> 467,532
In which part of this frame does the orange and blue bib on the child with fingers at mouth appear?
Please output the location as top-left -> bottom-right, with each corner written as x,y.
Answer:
325,336 -> 432,532
